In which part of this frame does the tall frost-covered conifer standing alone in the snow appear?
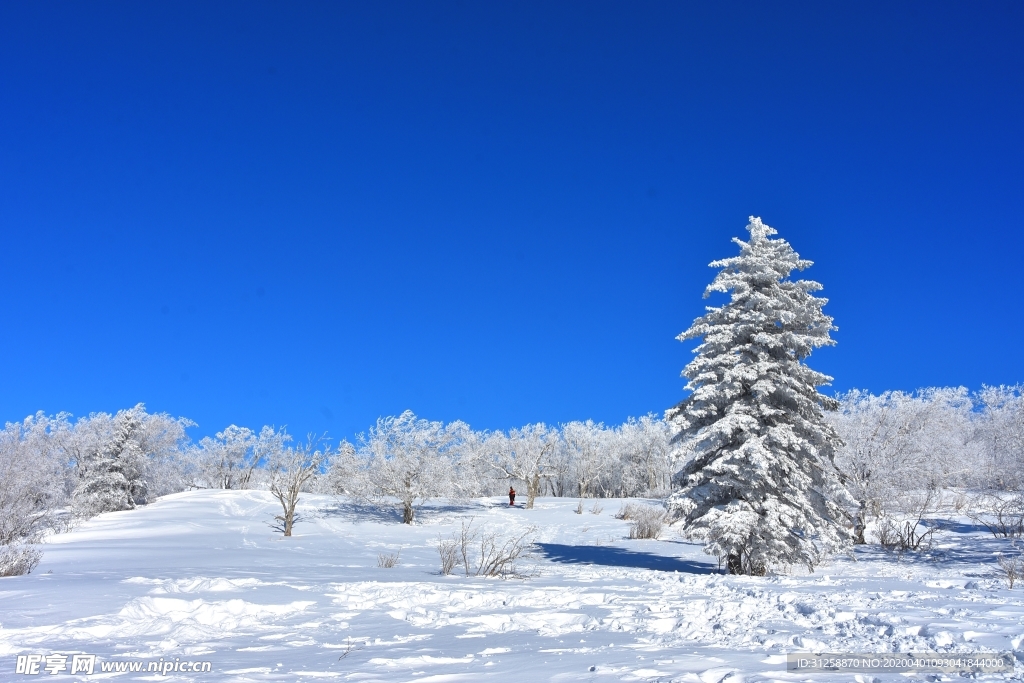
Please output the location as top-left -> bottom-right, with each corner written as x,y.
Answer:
666,216 -> 849,574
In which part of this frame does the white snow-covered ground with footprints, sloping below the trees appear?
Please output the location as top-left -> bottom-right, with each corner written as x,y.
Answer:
0,490 -> 1024,683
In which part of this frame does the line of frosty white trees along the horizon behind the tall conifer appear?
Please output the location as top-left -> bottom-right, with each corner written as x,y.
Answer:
0,386 -> 1024,545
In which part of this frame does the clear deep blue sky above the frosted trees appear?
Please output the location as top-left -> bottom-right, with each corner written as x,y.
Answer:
0,1 -> 1024,437
